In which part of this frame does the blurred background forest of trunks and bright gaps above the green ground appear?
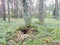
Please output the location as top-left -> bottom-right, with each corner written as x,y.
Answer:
0,0 -> 60,21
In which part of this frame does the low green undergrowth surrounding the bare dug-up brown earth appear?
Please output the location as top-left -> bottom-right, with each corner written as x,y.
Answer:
0,20 -> 60,45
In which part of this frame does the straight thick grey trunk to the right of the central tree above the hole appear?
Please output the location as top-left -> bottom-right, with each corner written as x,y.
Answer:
38,0 -> 44,23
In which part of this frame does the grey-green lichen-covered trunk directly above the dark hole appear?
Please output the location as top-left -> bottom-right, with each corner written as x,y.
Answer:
23,0 -> 31,25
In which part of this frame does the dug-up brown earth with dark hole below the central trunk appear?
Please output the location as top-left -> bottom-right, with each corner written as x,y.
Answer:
6,27 -> 38,44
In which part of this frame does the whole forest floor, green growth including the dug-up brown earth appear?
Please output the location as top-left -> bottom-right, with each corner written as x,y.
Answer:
0,18 -> 60,45
